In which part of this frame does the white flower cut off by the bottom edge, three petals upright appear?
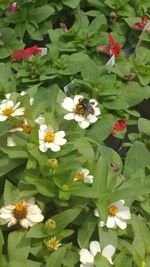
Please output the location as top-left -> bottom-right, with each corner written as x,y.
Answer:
79,241 -> 115,267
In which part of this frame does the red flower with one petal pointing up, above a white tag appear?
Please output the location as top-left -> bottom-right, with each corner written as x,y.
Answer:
97,33 -> 121,57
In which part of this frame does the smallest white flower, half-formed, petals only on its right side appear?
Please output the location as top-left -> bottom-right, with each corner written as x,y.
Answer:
74,168 -> 93,184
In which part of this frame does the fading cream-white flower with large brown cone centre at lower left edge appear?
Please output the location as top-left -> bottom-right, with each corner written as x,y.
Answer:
0,199 -> 44,229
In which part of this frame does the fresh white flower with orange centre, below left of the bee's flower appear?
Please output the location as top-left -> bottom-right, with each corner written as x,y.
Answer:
39,124 -> 67,152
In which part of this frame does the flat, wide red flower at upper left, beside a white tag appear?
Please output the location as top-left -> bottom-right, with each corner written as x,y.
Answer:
11,45 -> 42,61
